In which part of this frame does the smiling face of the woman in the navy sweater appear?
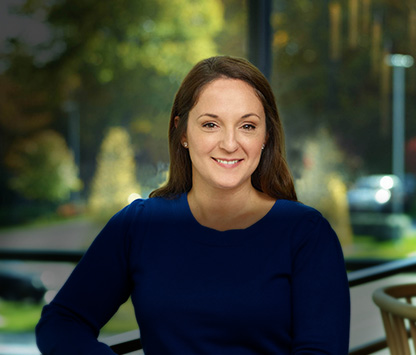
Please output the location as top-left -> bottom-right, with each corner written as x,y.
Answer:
182,78 -> 266,195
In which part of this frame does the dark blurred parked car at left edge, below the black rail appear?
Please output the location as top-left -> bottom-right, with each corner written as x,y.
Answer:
0,270 -> 47,303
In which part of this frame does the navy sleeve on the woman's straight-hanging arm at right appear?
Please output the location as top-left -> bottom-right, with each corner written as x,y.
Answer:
292,213 -> 350,355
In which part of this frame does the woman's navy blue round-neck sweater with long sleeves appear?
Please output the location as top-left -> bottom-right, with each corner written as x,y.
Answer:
36,194 -> 350,355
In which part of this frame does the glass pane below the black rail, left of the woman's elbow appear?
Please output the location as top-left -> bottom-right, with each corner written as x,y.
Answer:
0,260 -> 74,354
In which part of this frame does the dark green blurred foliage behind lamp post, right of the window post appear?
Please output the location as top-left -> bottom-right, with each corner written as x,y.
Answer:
272,0 -> 416,173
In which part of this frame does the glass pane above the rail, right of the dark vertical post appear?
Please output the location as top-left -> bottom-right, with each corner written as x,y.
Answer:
272,0 -> 416,260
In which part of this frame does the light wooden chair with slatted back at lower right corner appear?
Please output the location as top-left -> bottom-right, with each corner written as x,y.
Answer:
373,283 -> 416,355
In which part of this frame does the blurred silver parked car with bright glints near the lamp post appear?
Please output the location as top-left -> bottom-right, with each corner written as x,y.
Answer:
347,174 -> 406,212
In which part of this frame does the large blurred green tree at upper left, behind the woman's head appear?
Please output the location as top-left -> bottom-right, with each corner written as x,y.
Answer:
0,0 -> 224,203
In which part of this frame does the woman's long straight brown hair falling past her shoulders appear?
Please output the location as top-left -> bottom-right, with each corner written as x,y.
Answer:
150,56 -> 297,201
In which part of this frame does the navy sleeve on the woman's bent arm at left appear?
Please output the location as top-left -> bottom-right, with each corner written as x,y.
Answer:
36,204 -> 141,355
